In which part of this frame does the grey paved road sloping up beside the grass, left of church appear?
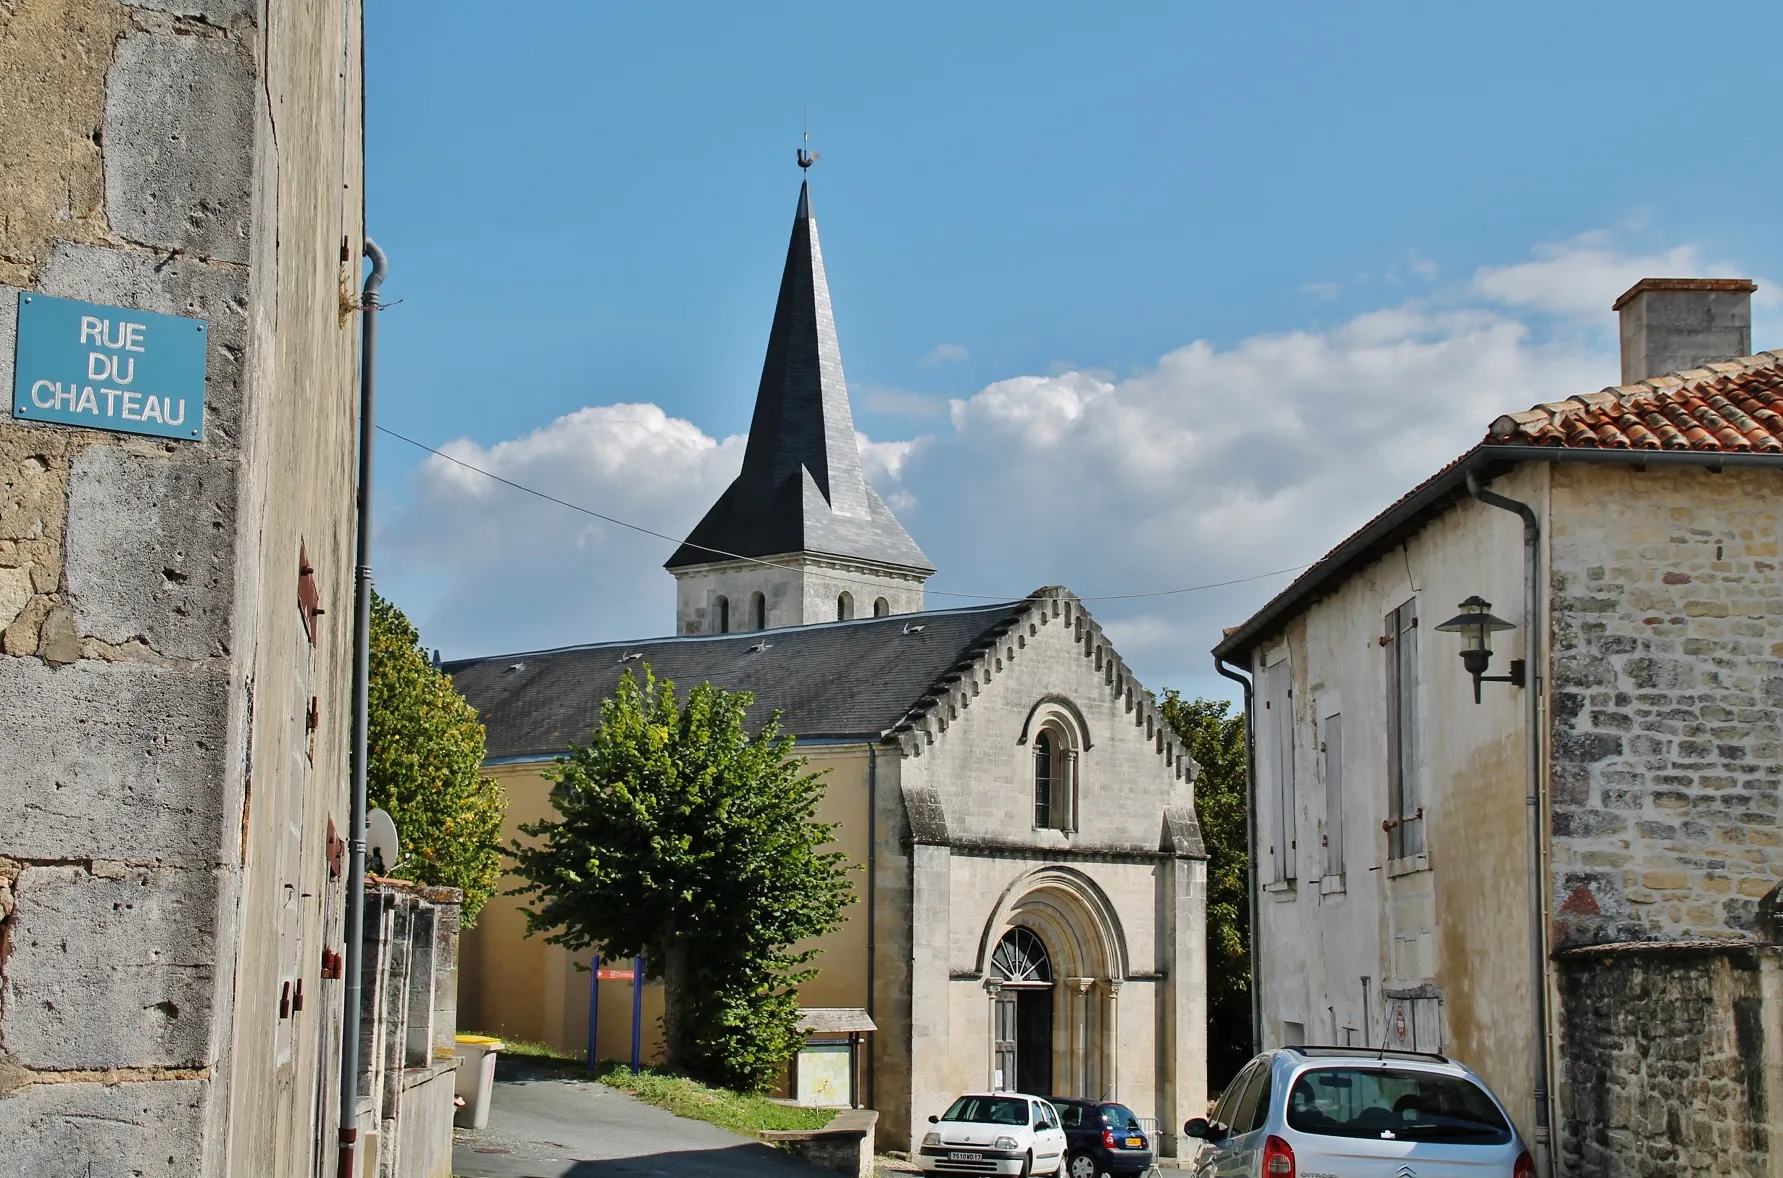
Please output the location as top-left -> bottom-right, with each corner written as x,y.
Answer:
453,1060 -> 826,1178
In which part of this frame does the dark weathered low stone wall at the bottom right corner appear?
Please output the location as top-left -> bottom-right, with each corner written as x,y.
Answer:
1557,941 -> 1783,1178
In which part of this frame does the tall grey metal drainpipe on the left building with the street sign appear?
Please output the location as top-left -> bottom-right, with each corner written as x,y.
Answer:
339,237 -> 389,1178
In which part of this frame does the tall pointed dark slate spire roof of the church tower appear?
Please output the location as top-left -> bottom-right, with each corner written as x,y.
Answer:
665,184 -> 934,572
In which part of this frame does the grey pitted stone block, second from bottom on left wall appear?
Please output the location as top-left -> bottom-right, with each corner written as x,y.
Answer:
0,866 -> 219,1069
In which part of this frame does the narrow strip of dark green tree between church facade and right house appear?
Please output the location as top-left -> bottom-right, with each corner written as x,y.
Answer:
1161,691 -> 1250,1091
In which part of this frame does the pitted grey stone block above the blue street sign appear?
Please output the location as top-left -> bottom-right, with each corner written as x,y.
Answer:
103,34 -> 255,264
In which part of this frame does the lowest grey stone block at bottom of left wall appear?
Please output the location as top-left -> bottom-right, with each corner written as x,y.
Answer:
0,1080 -> 210,1178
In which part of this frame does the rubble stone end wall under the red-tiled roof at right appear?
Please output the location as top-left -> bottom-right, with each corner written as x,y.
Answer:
1549,463 -> 1783,946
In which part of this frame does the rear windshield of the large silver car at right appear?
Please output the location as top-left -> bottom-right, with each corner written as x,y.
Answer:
1287,1068 -> 1510,1146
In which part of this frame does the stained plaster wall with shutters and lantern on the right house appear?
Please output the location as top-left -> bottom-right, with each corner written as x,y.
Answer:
1252,467 -> 1546,1128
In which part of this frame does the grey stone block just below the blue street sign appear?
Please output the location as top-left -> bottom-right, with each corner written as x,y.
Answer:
66,446 -> 235,659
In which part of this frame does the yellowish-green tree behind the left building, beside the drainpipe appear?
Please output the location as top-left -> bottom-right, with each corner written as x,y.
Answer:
366,593 -> 508,927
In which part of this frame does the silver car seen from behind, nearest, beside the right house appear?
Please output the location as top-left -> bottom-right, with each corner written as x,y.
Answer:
1182,1048 -> 1535,1178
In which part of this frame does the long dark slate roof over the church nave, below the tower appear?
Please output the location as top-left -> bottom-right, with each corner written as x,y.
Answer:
444,597 -> 1034,759
